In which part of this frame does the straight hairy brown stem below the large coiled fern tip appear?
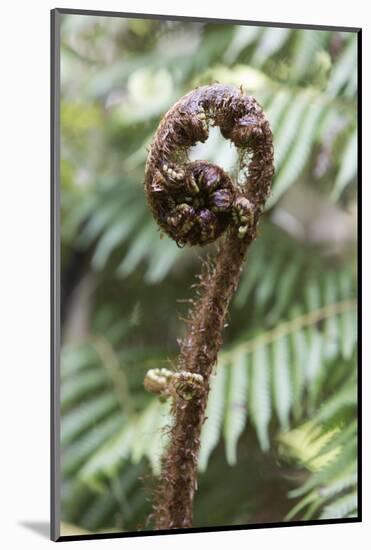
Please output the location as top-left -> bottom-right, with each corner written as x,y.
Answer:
155,236 -> 256,529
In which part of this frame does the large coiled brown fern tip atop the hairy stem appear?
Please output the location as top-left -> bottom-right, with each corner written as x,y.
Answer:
144,84 -> 274,246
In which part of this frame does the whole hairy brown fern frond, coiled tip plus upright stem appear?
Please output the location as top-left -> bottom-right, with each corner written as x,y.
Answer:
145,84 -> 274,529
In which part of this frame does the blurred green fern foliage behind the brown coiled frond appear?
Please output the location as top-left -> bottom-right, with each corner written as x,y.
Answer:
61,15 -> 357,533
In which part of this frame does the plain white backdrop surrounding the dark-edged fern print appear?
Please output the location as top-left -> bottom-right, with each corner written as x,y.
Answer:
0,0 -> 371,550
